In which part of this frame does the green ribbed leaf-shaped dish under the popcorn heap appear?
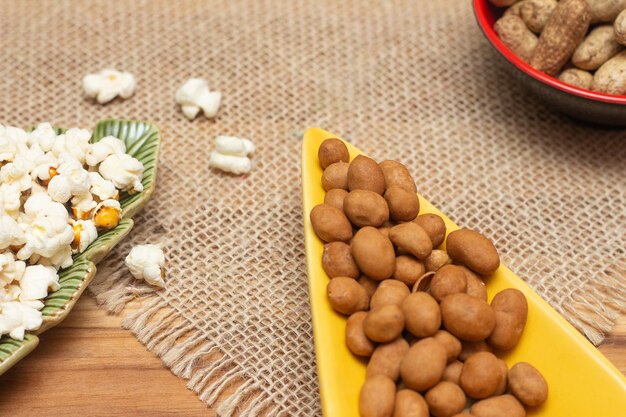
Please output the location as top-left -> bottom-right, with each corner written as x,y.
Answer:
0,119 -> 160,375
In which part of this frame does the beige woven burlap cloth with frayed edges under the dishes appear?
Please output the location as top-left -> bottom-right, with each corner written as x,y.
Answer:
0,0 -> 626,416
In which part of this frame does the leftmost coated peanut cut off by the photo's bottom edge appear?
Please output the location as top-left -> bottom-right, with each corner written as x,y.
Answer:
359,375 -> 396,417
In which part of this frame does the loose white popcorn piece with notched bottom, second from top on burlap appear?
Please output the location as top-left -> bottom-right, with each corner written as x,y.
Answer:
176,78 -> 222,120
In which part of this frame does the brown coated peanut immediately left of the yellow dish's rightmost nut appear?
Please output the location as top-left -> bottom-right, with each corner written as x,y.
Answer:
460,352 -> 502,400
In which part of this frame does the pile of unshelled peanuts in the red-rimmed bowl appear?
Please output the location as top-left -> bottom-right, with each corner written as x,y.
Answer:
490,0 -> 626,95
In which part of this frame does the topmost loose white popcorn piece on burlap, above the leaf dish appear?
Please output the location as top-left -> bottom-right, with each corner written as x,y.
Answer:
83,68 -> 137,104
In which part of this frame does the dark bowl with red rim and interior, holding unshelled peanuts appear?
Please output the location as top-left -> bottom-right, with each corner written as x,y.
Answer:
472,0 -> 626,126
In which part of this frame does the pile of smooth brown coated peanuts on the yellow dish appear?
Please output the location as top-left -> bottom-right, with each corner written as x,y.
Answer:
310,139 -> 548,417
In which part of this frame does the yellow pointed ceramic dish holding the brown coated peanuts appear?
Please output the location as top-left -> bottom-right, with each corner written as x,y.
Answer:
302,129 -> 626,417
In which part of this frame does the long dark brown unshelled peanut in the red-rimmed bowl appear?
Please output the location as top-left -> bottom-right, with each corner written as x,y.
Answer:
530,0 -> 591,75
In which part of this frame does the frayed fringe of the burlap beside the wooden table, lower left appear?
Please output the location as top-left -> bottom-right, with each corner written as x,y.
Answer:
122,295 -> 278,417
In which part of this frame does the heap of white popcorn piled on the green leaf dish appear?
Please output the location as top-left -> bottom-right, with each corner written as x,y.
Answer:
0,120 -> 146,339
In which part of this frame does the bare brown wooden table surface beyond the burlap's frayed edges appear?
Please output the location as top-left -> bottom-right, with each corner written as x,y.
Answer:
0,295 -> 626,417
